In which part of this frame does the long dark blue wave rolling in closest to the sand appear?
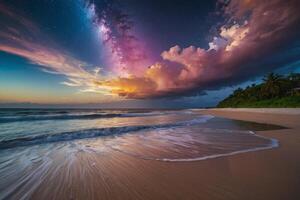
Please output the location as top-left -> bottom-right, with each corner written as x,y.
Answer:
0,115 -> 213,149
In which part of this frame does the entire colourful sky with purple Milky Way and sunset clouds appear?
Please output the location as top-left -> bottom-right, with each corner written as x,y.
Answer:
0,0 -> 300,108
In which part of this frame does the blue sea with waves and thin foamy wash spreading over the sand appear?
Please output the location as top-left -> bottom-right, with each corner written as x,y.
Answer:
0,109 -> 281,199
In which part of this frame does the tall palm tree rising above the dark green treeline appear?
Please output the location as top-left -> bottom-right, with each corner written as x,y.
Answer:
262,73 -> 282,98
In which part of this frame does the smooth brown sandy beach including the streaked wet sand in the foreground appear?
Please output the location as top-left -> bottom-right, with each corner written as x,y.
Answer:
21,110 -> 300,200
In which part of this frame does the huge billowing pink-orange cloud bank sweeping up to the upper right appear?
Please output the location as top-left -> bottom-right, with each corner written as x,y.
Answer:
98,0 -> 300,98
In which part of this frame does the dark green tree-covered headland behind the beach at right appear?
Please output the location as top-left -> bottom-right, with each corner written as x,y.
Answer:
217,73 -> 300,108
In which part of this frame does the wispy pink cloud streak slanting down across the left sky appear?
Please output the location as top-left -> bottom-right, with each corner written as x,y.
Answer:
0,4 -> 108,95
